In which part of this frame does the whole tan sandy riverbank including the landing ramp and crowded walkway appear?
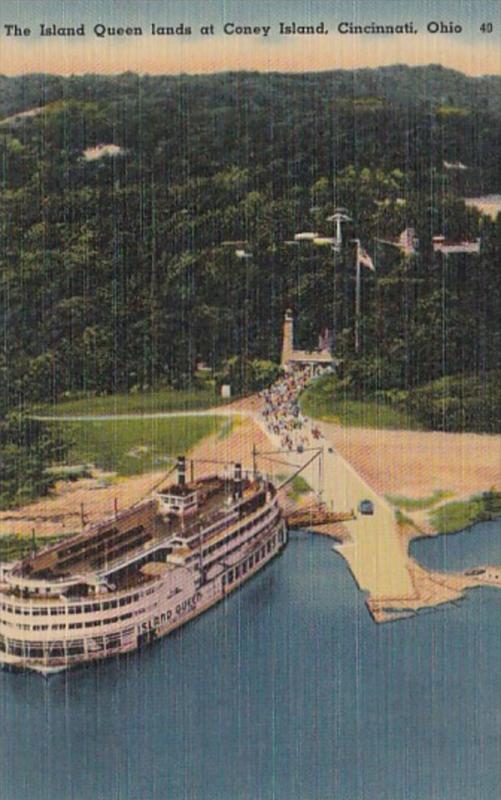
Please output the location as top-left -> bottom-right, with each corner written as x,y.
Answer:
0,365 -> 500,622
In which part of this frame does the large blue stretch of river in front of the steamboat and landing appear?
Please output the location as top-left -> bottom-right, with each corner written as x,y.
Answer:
0,534 -> 501,800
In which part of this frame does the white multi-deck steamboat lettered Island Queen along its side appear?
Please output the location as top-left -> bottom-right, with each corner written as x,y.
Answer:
0,457 -> 287,675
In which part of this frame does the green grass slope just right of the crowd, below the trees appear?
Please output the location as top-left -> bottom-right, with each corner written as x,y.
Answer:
300,376 -> 421,430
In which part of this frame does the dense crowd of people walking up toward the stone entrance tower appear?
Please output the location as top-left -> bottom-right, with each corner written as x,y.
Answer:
260,365 -> 323,451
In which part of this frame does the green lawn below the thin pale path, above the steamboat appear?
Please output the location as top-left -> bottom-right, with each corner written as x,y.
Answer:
50,416 -> 227,475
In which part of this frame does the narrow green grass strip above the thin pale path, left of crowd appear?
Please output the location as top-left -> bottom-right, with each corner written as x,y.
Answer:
35,387 -> 231,416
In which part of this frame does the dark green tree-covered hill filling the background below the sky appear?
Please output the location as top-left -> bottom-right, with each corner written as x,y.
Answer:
0,66 -> 501,430
